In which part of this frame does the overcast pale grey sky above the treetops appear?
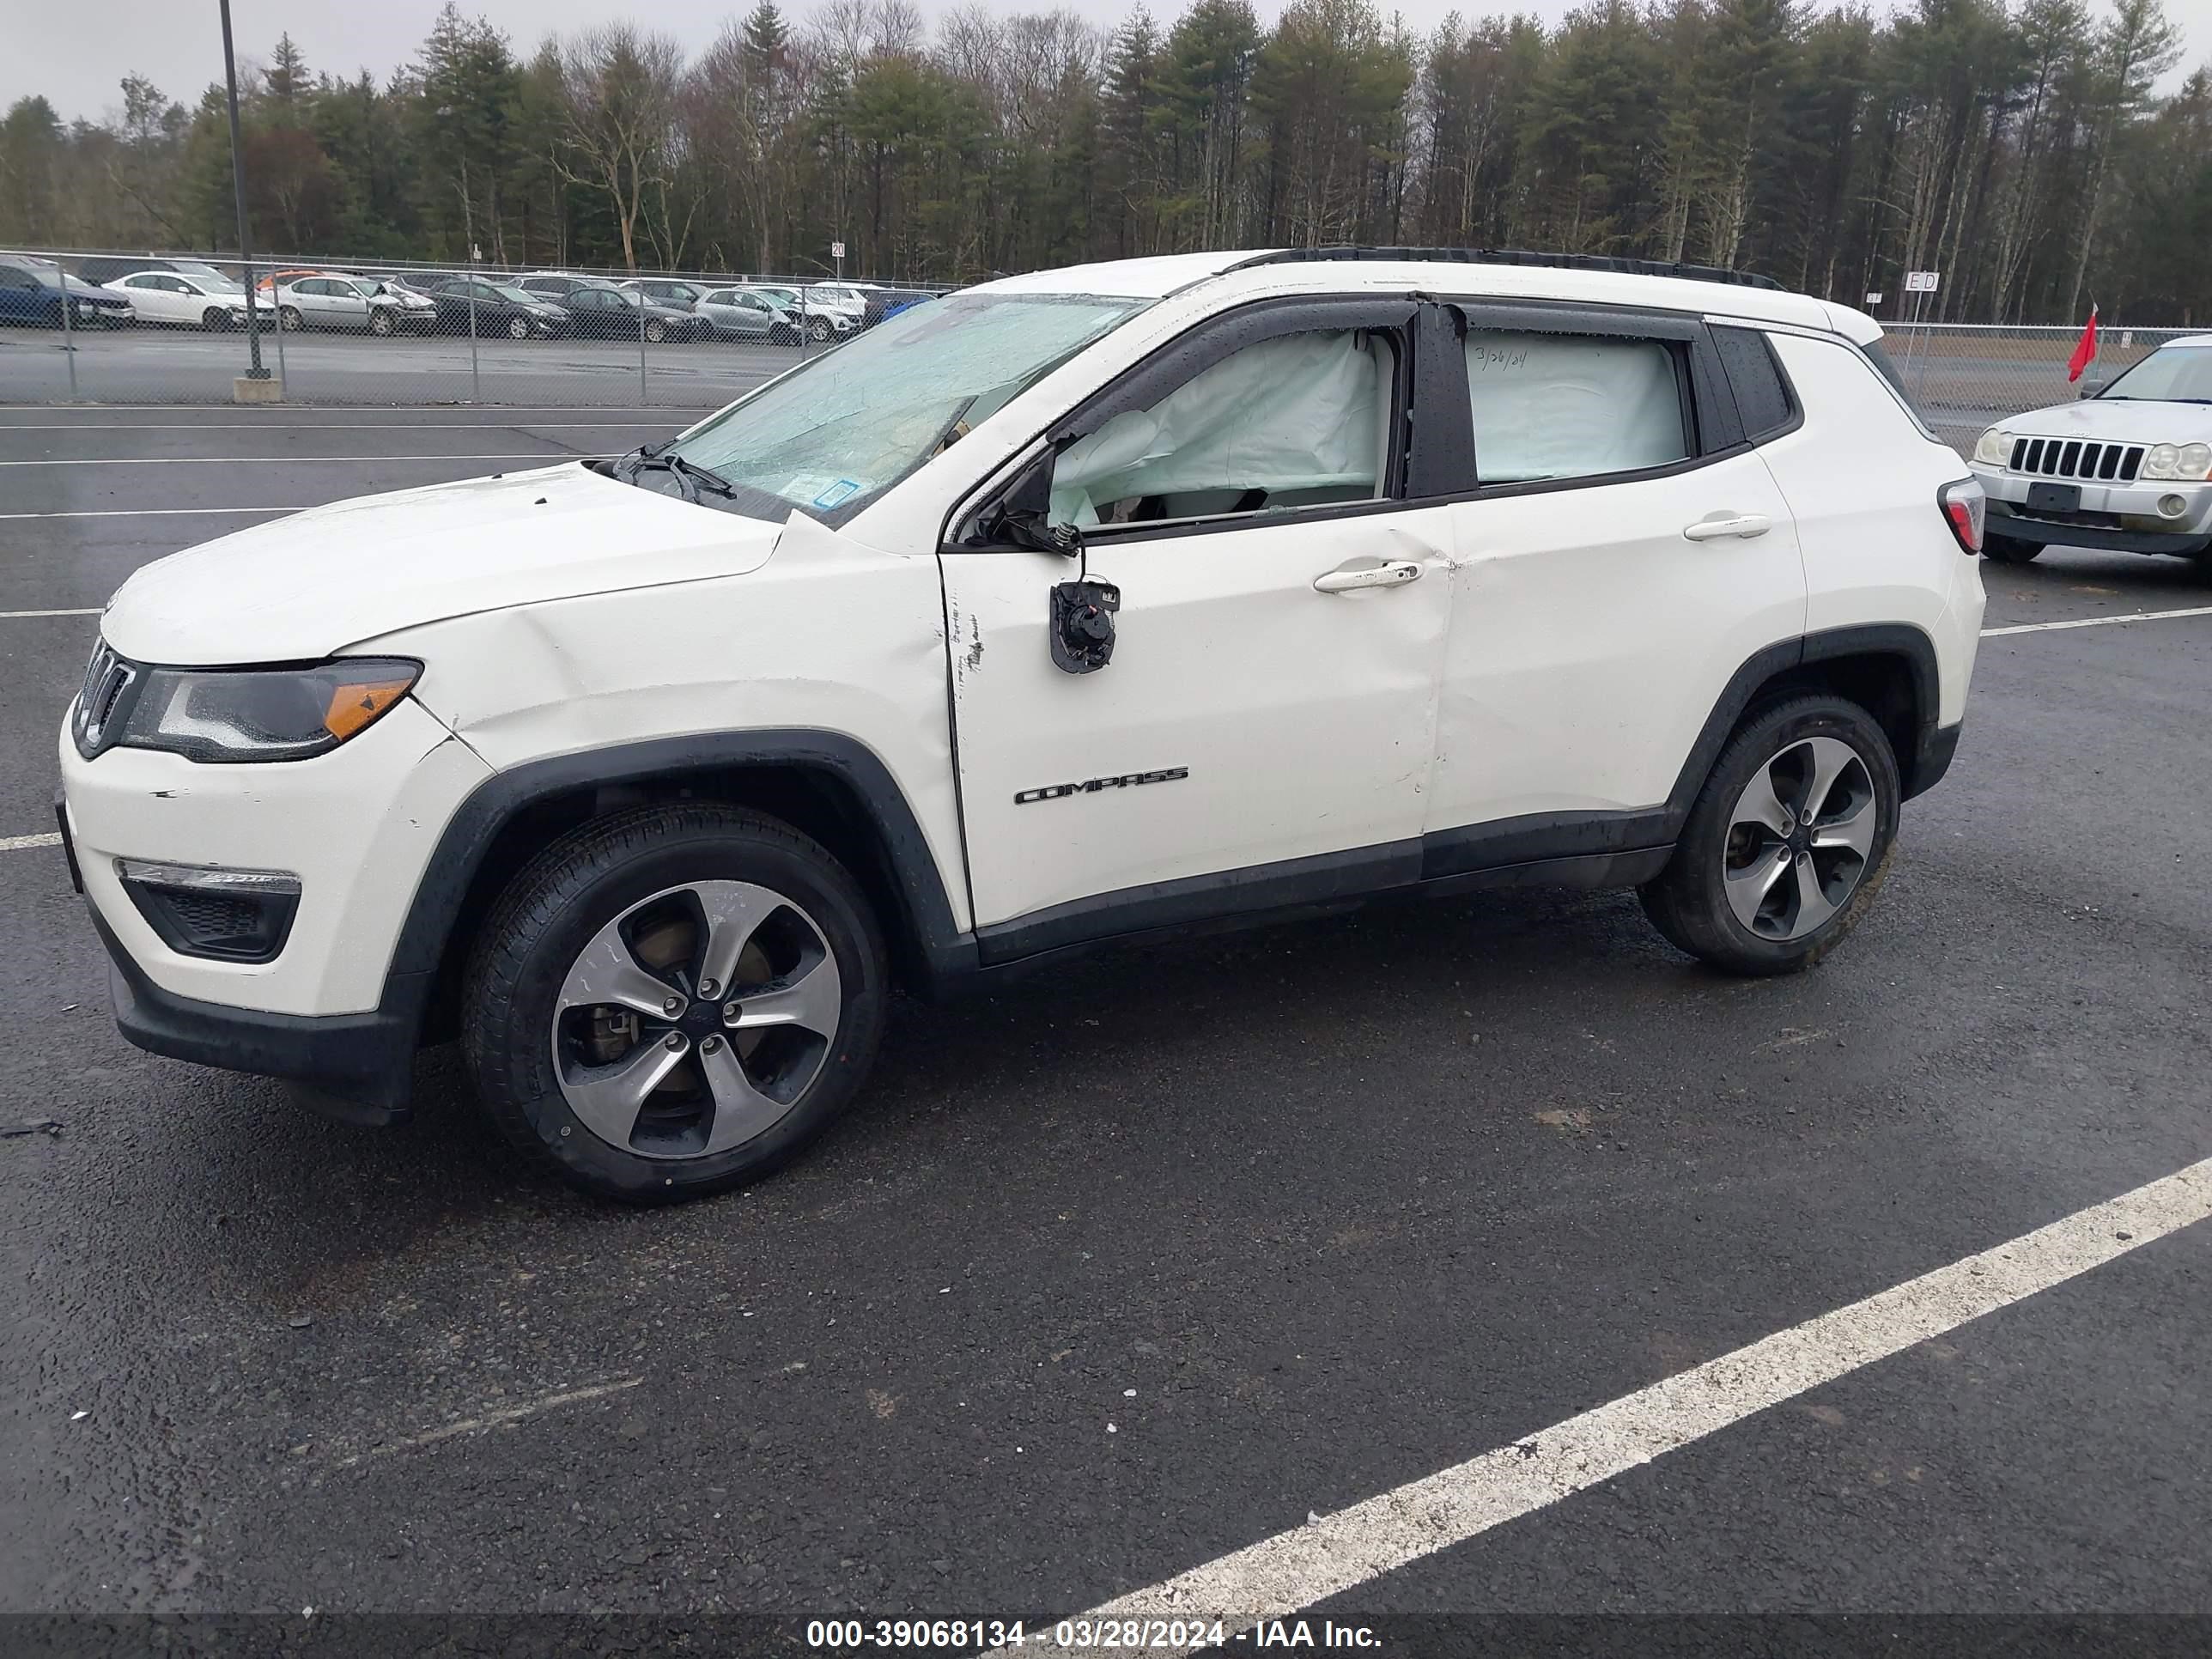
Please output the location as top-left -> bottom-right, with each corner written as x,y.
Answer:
13,0 -> 2212,119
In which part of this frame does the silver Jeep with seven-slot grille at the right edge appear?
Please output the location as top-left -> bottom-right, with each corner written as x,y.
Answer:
1973,334 -> 2212,564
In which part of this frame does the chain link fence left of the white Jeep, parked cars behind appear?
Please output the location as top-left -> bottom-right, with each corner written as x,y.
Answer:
0,248 -> 964,410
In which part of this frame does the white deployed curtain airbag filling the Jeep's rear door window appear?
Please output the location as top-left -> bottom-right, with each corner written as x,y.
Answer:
1467,330 -> 1690,484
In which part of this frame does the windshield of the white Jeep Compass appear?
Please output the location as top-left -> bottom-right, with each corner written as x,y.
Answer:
665,295 -> 1146,522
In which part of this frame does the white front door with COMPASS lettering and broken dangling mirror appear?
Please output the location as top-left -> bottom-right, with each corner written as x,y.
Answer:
940,299 -> 1451,963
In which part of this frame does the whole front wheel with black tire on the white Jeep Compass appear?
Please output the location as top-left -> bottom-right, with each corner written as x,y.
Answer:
462,803 -> 887,1203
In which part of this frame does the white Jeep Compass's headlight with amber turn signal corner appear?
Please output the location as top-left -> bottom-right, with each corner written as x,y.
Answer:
100,657 -> 422,761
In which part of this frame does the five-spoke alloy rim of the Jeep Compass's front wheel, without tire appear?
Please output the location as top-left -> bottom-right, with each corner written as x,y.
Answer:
550,880 -> 845,1159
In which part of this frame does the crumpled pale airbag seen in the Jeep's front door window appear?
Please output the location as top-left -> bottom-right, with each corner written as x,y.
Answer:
1053,330 -> 1380,525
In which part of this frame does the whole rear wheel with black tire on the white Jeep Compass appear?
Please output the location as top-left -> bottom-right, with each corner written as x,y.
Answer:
1637,695 -> 1905,975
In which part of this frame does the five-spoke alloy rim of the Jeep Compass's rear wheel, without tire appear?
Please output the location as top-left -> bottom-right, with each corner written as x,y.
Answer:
1723,737 -> 1881,940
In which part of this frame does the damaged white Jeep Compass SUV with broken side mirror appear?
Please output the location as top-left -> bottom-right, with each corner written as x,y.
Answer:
60,250 -> 1982,1199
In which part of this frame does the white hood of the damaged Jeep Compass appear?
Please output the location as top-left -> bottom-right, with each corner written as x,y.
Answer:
100,465 -> 783,665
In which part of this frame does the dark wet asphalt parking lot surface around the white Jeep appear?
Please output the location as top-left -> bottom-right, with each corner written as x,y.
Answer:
0,404 -> 2212,1626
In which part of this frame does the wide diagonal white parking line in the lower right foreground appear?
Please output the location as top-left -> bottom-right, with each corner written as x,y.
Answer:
1030,1159 -> 2212,1650
